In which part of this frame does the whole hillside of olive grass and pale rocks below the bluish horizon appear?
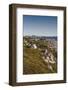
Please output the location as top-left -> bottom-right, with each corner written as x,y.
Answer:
23,37 -> 57,74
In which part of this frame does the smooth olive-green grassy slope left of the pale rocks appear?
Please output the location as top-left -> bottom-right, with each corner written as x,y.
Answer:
23,48 -> 51,74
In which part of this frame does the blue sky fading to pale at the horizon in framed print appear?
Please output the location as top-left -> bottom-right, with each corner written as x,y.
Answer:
23,15 -> 57,36
